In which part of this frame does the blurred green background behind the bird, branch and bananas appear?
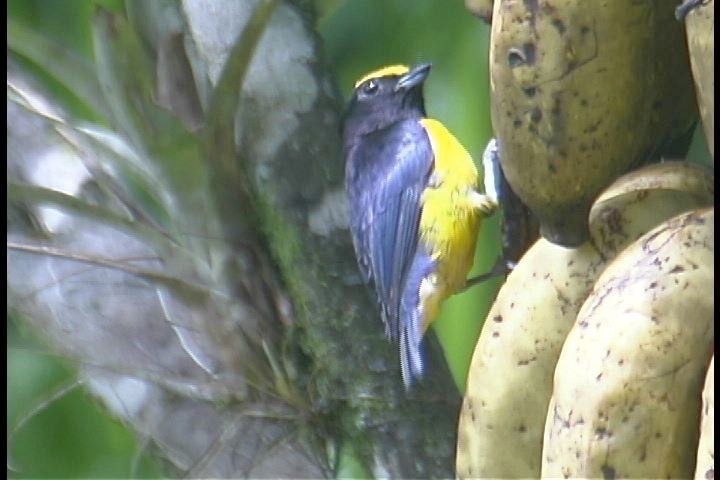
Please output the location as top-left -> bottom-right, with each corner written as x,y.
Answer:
7,0 -> 709,478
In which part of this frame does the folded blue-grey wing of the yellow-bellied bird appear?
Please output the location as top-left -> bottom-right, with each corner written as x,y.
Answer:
350,121 -> 433,339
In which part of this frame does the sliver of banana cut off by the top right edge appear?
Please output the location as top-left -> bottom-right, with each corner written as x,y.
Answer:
685,0 -> 715,160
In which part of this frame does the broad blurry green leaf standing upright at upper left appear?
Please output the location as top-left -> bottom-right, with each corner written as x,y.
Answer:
94,6 -> 220,248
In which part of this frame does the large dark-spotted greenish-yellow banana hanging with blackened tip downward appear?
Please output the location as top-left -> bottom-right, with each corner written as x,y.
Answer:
490,0 -> 697,246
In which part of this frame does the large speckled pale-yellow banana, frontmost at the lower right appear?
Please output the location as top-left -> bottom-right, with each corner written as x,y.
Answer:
541,208 -> 715,478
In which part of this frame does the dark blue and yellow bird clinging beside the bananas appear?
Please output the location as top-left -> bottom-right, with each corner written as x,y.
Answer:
342,63 -> 497,389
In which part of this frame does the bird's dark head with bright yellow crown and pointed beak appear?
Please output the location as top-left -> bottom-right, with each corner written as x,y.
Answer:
343,63 -> 430,139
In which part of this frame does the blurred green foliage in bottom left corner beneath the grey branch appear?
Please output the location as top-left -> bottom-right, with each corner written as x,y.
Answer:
7,315 -> 160,478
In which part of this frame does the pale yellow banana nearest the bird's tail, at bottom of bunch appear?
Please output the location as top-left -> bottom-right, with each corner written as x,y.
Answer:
456,239 -> 605,478
